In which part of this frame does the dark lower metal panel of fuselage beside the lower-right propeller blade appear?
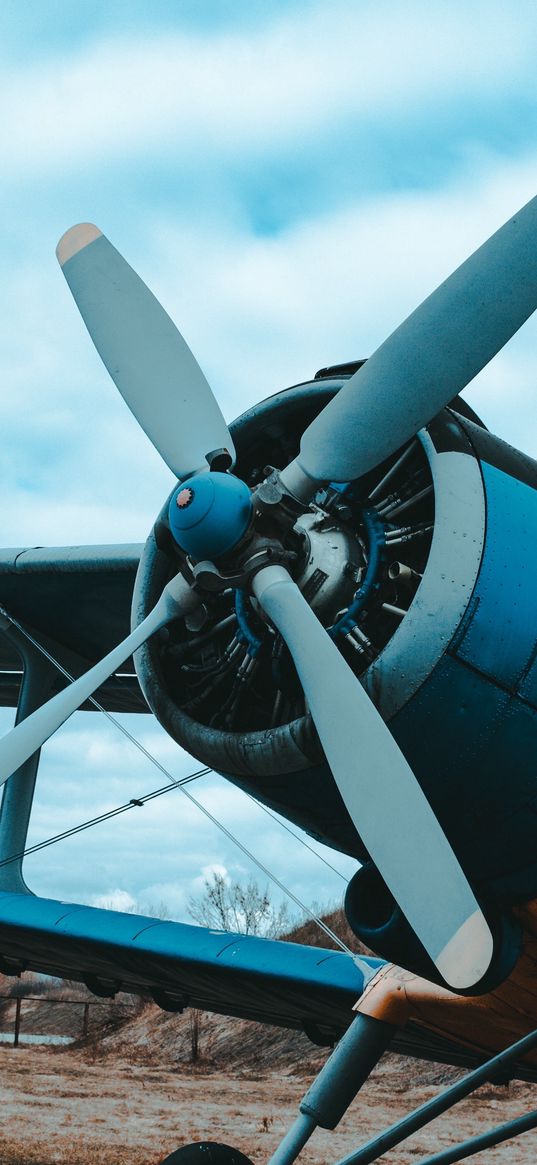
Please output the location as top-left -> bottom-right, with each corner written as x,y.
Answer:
390,655 -> 537,902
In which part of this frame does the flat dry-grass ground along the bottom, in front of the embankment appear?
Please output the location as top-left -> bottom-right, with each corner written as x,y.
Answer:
0,1046 -> 537,1165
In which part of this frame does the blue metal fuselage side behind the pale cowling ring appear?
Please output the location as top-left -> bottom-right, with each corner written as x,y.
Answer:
389,463 -> 537,902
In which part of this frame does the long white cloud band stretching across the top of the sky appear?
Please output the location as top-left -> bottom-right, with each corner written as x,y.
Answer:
0,0 -> 535,174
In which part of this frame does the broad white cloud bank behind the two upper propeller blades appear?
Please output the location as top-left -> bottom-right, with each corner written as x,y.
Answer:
0,127 -> 537,545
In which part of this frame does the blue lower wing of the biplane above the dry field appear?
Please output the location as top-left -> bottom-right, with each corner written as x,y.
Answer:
0,894 -> 537,1080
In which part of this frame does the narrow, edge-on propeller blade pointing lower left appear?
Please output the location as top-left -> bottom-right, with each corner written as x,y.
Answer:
0,574 -> 199,784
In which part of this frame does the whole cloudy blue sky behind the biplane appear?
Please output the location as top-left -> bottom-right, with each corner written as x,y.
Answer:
0,0 -> 537,918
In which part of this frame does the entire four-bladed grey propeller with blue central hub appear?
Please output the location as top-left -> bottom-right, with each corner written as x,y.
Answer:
0,199 -> 537,989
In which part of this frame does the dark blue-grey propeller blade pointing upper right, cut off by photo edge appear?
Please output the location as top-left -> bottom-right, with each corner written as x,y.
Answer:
282,198 -> 537,501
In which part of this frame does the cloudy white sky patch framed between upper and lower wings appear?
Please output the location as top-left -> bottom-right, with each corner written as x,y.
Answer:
16,713 -> 354,922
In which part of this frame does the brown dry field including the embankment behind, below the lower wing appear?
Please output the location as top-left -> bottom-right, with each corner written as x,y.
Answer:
0,915 -> 537,1165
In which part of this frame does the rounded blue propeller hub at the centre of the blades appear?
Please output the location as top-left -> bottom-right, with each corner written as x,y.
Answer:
168,472 -> 253,562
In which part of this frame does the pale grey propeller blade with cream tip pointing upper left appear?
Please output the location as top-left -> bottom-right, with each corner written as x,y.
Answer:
56,223 -> 235,478
